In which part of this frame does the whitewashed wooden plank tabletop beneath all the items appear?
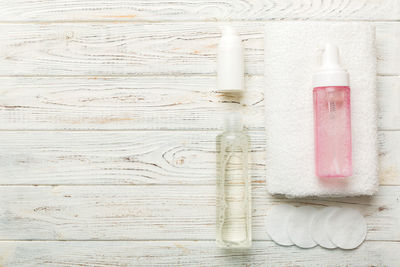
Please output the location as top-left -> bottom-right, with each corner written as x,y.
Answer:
0,0 -> 400,266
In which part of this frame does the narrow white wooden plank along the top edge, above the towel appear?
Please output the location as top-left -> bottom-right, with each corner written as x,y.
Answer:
0,0 -> 400,21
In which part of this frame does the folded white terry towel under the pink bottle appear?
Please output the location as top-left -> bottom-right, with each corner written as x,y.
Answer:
264,22 -> 379,197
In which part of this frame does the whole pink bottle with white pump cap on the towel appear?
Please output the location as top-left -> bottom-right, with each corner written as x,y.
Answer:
313,44 -> 352,177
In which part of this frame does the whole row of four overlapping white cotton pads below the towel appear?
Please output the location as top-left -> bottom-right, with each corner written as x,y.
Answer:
267,204 -> 367,249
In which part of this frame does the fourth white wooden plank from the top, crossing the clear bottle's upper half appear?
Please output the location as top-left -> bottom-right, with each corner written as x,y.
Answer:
0,131 -> 400,185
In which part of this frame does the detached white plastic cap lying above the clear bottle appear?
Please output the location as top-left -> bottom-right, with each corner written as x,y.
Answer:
217,26 -> 244,92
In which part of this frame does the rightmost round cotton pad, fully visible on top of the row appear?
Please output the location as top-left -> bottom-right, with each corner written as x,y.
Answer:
326,208 -> 367,249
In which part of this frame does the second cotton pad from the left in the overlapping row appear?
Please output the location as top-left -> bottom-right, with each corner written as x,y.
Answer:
287,206 -> 317,248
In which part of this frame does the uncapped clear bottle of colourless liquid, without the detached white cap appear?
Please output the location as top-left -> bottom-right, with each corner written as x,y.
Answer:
216,113 -> 251,248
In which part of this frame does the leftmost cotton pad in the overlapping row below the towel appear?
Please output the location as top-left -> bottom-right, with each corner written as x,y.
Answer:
266,204 -> 296,246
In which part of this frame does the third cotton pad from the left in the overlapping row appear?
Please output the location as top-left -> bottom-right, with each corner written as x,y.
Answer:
310,207 -> 339,248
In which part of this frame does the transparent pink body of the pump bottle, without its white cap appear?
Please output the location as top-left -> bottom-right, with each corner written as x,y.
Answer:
314,86 -> 352,177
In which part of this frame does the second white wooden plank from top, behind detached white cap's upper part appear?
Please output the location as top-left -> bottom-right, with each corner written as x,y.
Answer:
0,22 -> 400,76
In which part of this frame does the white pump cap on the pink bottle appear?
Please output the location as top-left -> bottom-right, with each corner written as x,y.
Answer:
313,43 -> 349,88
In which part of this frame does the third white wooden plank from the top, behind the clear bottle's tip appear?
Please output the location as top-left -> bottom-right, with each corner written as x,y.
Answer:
0,76 -> 400,130
